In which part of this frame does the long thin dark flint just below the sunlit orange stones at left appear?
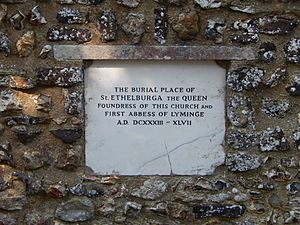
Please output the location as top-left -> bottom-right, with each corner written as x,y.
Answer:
5,115 -> 50,126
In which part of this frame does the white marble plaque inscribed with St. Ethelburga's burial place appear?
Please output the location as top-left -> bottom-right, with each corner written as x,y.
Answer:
85,61 -> 225,175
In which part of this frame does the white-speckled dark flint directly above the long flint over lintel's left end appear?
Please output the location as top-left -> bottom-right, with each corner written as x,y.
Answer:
56,7 -> 84,24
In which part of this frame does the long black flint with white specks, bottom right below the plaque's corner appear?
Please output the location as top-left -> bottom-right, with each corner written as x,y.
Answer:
193,205 -> 246,219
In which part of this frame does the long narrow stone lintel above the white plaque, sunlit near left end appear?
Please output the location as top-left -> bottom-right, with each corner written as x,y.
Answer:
54,45 -> 256,61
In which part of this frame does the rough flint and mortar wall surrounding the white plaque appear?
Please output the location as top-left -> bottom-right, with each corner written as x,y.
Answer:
0,0 -> 300,225
